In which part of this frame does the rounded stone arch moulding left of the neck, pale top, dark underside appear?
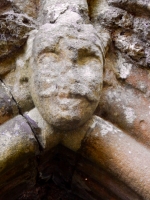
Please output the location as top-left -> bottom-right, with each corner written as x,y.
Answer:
0,115 -> 39,199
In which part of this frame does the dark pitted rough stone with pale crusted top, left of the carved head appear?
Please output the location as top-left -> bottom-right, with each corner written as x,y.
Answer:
0,11 -> 35,58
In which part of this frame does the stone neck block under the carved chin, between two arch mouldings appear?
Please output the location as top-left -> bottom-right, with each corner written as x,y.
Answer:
25,108 -> 92,152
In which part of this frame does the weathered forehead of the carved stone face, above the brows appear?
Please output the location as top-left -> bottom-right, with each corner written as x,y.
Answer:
33,24 -> 102,58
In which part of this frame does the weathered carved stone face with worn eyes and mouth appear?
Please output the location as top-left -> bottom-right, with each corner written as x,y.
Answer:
31,23 -> 103,130
